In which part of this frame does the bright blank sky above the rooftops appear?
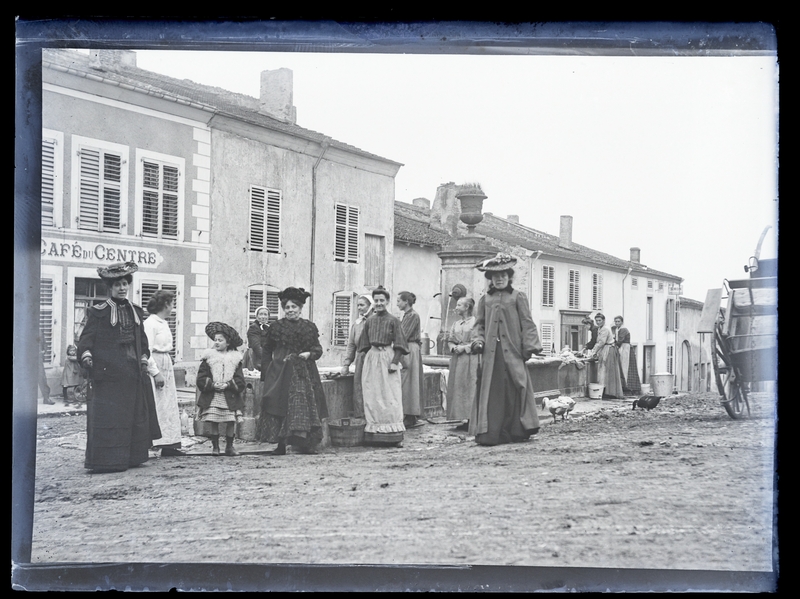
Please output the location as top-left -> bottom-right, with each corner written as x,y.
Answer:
137,51 -> 778,301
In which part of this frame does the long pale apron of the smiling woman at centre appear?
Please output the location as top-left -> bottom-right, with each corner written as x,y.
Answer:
361,346 -> 406,433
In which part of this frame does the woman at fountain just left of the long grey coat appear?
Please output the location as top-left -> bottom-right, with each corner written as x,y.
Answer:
447,297 -> 481,430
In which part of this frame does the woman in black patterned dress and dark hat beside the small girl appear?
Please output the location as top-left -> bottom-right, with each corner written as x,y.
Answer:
256,287 -> 328,455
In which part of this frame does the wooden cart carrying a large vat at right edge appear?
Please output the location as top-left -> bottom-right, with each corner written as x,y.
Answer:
698,229 -> 778,419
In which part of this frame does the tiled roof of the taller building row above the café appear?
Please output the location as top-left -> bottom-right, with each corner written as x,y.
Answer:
42,49 -> 402,166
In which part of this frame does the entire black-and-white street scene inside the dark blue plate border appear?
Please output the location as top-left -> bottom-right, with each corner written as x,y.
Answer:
14,23 -> 779,591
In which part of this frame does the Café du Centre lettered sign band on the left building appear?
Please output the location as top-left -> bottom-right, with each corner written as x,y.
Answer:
42,237 -> 164,268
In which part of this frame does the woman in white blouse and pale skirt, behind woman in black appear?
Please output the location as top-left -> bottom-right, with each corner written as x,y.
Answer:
144,290 -> 186,457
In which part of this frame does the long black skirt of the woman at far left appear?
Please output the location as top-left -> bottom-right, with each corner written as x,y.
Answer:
84,362 -> 152,470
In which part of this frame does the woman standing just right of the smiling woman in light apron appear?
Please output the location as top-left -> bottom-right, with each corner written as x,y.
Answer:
397,291 -> 425,429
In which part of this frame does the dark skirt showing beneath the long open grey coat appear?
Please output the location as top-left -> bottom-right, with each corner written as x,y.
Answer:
475,343 -> 538,445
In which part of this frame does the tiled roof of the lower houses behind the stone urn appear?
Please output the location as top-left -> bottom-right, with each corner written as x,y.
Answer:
395,202 -> 681,280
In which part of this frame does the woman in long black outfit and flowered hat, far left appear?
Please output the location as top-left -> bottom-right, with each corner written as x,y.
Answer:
78,262 -> 161,472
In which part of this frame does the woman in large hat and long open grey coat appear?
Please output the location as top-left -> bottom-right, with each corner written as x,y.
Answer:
469,253 -> 542,445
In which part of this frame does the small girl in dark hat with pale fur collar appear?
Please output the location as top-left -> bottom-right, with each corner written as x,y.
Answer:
197,322 -> 245,456
